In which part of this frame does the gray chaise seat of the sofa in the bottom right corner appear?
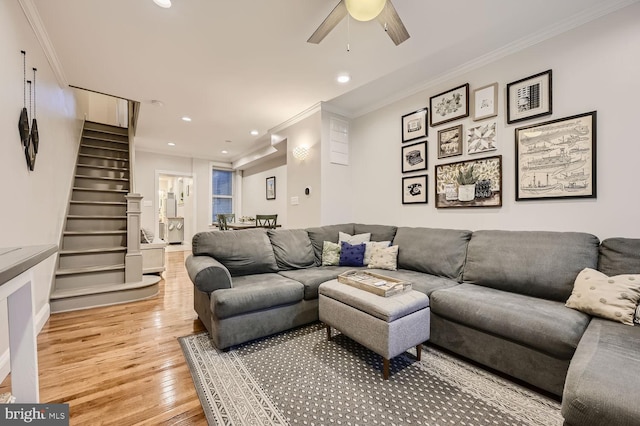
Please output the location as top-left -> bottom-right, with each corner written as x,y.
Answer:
562,318 -> 640,426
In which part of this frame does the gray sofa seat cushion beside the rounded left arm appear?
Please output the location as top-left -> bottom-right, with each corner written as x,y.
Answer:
211,272 -> 304,319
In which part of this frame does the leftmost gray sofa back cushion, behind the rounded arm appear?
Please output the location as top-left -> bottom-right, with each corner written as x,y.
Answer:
191,228 -> 278,276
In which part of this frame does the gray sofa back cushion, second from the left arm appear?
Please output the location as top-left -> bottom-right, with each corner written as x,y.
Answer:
267,229 -> 316,271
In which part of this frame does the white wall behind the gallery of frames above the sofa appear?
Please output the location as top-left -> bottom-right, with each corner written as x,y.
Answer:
351,4 -> 640,239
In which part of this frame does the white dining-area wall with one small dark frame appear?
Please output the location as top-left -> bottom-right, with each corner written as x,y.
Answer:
241,155 -> 287,227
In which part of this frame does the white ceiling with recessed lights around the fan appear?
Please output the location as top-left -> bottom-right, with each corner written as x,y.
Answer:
31,0 -> 635,162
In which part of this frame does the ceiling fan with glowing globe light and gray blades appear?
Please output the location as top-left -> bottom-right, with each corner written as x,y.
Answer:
307,0 -> 410,46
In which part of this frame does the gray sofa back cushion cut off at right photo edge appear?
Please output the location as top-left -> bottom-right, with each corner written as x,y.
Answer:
598,238 -> 640,276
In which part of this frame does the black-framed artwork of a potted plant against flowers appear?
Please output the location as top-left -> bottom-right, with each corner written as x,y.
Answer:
436,155 -> 502,208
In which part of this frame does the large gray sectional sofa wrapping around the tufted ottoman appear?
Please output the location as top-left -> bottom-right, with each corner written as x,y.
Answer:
186,223 -> 640,426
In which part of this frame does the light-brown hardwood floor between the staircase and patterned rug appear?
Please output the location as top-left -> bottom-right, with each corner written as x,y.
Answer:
0,252 -> 207,425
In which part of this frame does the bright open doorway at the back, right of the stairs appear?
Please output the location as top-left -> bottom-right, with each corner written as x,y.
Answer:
156,171 -> 195,251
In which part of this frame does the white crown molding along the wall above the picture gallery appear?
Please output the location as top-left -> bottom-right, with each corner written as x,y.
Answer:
347,0 -> 640,118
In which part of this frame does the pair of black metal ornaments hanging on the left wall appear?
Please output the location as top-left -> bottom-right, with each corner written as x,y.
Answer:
18,50 -> 40,171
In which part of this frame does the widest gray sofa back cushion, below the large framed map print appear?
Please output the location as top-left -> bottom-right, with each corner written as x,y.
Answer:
464,231 -> 600,302
